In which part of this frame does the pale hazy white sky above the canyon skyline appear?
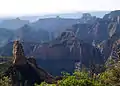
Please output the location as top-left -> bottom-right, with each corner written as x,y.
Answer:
0,0 -> 120,16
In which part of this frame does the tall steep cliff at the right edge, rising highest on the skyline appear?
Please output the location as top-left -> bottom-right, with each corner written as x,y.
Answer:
99,10 -> 120,60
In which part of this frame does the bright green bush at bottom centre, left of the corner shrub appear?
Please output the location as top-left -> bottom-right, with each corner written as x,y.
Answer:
36,71 -> 105,86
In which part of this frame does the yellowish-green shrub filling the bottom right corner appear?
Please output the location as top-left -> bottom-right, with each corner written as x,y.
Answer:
101,61 -> 120,86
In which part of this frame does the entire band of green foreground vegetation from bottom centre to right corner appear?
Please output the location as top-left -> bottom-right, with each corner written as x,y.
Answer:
35,61 -> 120,86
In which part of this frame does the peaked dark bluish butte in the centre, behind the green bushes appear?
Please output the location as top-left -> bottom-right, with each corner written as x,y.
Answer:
33,31 -> 104,75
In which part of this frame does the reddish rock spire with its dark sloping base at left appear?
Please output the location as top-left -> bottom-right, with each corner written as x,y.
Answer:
4,41 -> 55,86
